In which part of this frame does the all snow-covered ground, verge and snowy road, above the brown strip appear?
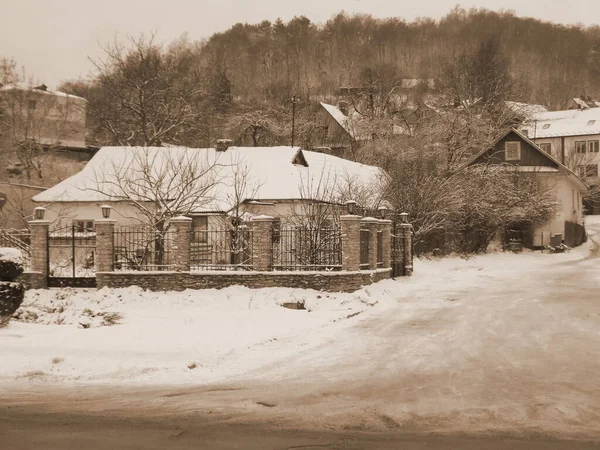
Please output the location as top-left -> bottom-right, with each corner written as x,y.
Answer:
0,216 -> 600,435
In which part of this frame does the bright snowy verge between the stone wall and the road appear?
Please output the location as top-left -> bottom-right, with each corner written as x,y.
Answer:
0,239 -> 587,384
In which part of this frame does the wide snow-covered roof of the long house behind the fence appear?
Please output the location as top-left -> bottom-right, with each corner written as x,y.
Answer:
32,146 -> 380,212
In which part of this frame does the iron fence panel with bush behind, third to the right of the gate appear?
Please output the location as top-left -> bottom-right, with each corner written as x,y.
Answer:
271,226 -> 342,270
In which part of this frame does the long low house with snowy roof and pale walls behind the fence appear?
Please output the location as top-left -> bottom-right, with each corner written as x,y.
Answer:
32,145 -> 380,229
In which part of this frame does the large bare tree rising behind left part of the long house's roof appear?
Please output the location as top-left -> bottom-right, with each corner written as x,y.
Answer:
65,35 -> 206,146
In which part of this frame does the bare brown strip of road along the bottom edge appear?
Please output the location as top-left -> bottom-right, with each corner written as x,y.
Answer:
0,407 -> 600,450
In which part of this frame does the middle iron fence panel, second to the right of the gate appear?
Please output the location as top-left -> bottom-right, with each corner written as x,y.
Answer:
190,226 -> 253,270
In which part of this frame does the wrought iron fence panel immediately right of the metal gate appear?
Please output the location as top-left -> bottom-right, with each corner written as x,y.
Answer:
114,227 -> 174,271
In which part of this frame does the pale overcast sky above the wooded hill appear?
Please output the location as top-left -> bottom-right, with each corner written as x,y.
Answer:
0,0 -> 600,88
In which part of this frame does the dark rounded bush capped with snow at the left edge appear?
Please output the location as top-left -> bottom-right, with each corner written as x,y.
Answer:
0,248 -> 25,325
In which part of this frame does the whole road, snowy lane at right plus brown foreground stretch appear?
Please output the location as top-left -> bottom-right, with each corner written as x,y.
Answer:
0,219 -> 600,450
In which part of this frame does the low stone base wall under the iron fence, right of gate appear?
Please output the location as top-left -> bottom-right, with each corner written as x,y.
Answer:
96,268 -> 391,292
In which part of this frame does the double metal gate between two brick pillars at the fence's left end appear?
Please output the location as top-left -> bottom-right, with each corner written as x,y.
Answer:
48,222 -> 96,287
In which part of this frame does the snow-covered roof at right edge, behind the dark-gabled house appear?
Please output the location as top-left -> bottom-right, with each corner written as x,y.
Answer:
521,108 -> 600,139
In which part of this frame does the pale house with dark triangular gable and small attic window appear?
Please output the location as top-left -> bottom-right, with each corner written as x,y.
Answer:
469,129 -> 588,247
